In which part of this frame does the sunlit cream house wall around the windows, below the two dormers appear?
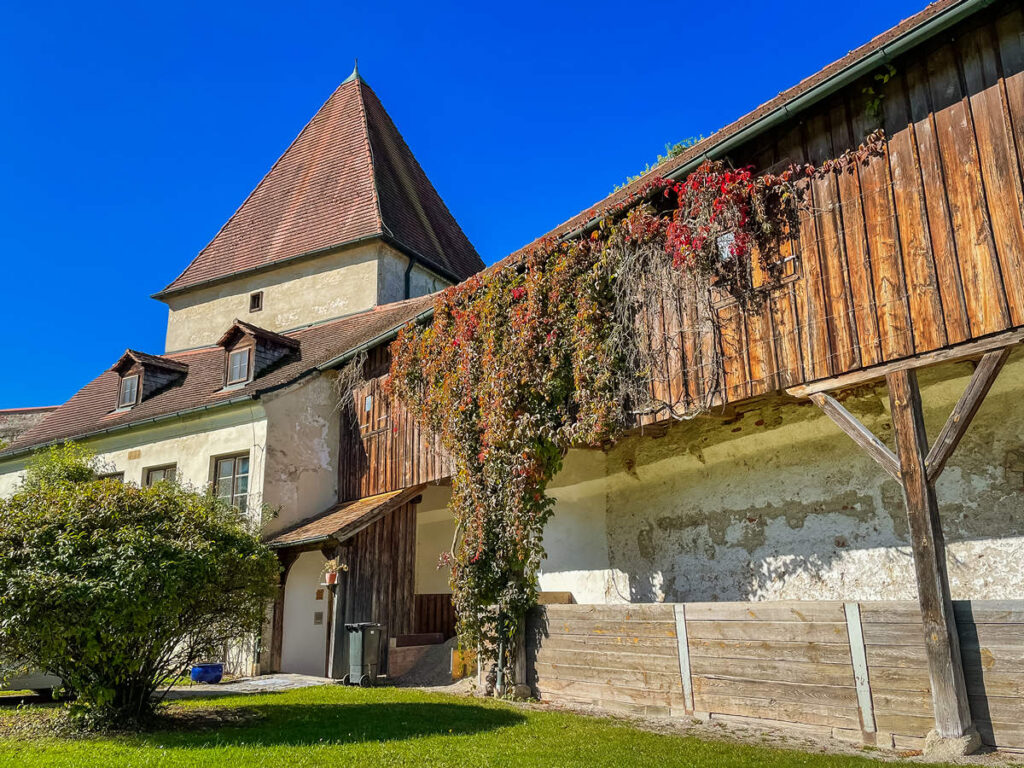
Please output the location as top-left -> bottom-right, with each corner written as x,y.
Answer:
0,401 -> 266,515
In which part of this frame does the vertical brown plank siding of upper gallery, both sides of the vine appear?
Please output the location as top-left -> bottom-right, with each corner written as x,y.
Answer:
339,2 -> 1024,500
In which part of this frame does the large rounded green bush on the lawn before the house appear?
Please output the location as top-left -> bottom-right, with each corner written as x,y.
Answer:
0,457 -> 278,727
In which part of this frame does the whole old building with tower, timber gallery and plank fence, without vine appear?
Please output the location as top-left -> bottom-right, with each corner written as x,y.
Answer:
0,0 -> 1024,755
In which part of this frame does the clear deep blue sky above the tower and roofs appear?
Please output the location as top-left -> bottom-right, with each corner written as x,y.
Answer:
0,0 -> 925,408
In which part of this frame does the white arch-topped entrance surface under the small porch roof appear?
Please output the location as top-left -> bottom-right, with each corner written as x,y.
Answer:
281,552 -> 328,677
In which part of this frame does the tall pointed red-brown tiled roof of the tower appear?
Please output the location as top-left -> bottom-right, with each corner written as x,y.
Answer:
157,72 -> 483,297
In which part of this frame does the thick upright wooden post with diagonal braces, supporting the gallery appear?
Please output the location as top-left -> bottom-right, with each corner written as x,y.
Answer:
886,371 -> 977,738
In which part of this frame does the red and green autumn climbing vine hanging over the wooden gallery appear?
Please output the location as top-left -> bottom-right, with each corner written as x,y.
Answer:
389,133 -> 883,663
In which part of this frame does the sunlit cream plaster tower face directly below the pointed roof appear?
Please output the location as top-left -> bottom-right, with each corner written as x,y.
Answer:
165,242 -> 391,352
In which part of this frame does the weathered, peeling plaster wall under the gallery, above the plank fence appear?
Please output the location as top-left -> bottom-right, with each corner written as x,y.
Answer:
598,353 -> 1024,602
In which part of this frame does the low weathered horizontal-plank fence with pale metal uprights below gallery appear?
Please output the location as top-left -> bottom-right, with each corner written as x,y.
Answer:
527,600 -> 1024,750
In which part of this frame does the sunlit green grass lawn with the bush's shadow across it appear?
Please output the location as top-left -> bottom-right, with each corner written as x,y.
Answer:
0,686 -> 937,768
